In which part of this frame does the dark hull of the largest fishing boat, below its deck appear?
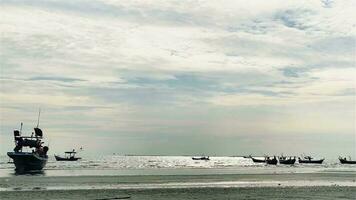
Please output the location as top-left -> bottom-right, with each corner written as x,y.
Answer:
7,152 -> 48,172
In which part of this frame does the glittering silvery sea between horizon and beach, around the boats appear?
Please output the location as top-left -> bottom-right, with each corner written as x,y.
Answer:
0,155 -> 356,177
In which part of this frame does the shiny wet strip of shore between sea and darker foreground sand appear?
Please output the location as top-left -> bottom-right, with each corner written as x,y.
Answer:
0,172 -> 356,192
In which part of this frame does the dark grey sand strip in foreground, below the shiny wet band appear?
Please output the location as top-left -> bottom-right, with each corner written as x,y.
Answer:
0,186 -> 356,200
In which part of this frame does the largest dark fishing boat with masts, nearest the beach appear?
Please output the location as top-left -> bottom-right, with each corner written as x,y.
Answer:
7,111 -> 49,173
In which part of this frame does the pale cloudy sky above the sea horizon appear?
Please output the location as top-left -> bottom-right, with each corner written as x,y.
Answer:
0,0 -> 356,157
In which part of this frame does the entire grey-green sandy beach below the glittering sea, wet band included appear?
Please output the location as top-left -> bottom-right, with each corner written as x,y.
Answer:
0,172 -> 356,200
